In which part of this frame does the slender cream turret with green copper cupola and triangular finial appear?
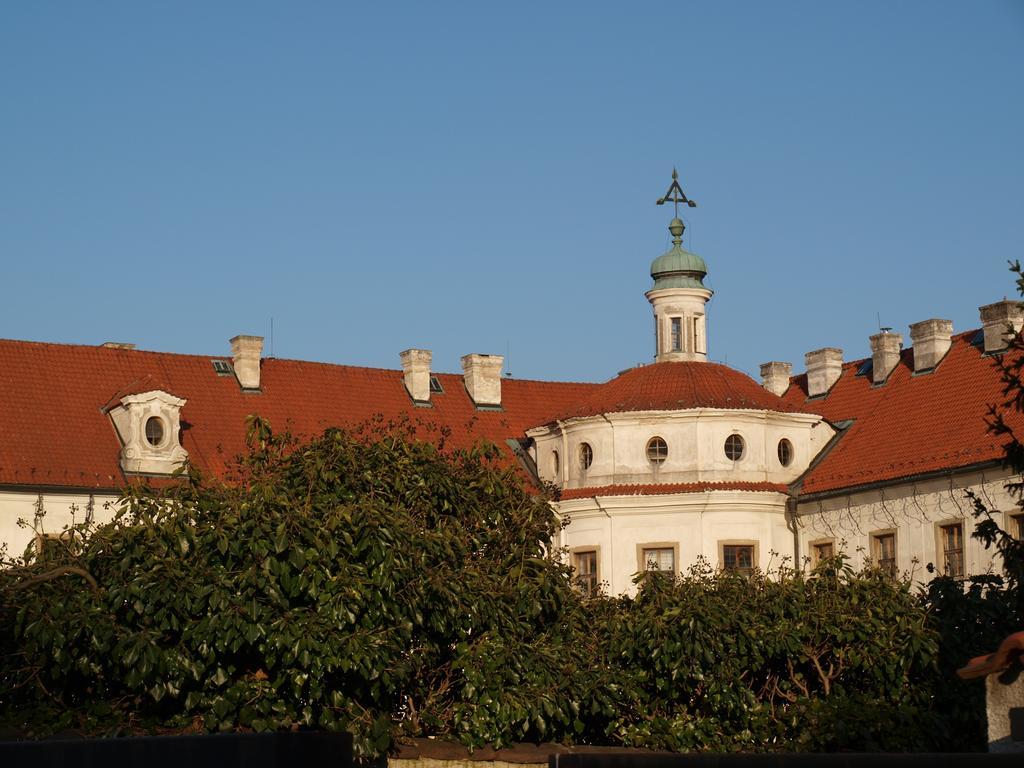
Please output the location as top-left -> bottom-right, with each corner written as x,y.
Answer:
645,169 -> 714,362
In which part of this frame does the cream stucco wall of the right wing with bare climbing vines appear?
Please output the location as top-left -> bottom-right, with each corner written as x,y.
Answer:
797,469 -> 1020,581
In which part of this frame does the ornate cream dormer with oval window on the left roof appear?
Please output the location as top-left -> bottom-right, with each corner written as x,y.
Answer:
108,389 -> 188,475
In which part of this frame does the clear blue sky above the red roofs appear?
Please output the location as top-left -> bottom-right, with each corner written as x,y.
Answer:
0,0 -> 1024,381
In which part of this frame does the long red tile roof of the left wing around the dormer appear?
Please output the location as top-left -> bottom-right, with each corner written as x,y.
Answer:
0,340 -> 595,488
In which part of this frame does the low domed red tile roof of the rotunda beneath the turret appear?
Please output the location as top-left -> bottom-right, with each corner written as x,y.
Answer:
549,362 -> 801,421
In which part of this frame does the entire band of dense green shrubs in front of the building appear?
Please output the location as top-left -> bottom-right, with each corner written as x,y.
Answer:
0,405 -> 1006,756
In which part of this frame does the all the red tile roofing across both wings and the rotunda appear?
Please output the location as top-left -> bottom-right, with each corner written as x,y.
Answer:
0,331 -> 1024,499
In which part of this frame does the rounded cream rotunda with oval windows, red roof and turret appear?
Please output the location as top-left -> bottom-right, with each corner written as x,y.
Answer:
527,175 -> 836,594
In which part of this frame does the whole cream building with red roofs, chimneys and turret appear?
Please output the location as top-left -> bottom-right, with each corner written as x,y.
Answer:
0,178 -> 1024,594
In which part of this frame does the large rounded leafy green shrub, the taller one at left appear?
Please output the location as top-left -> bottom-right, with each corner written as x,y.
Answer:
0,420 -> 609,755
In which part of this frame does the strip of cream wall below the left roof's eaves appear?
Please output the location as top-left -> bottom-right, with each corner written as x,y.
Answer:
0,490 -> 118,556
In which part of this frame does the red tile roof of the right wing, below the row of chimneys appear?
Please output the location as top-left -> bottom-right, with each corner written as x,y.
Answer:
783,331 -> 1021,495
